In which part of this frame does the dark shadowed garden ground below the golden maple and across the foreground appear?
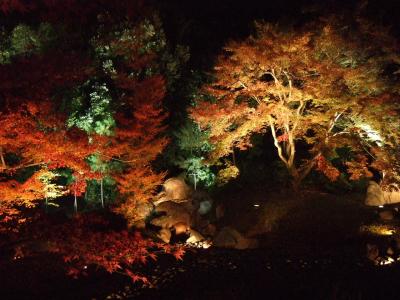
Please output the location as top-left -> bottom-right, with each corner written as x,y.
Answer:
1,192 -> 400,299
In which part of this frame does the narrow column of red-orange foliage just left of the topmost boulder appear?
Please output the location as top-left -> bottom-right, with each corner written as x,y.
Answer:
103,65 -> 167,223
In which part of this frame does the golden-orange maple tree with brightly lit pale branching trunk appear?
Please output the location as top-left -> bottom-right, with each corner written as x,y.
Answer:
190,18 -> 399,189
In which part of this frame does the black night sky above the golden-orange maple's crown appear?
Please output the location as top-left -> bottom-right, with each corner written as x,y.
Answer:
156,0 -> 400,67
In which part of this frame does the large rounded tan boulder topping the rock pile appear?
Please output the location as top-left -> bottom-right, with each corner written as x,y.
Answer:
154,177 -> 192,206
